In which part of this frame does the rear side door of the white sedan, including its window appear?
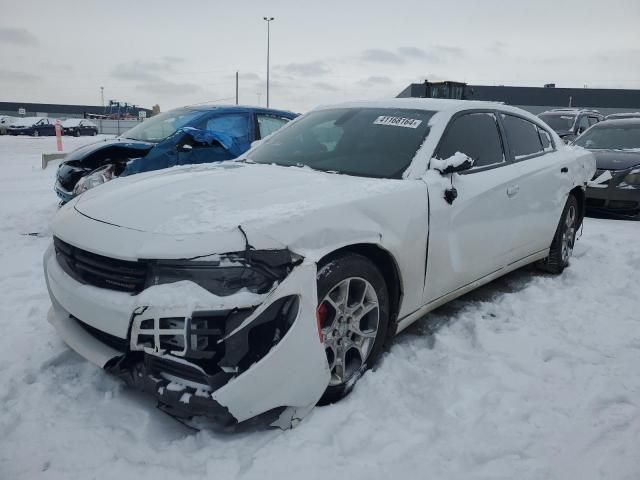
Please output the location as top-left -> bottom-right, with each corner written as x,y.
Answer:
500,113 -> 572,263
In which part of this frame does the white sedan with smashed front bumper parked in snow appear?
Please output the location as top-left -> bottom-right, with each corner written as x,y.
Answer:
44,99 -> 595,428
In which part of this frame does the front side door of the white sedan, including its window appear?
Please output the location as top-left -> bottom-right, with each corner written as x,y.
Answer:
424,111 -> 517,303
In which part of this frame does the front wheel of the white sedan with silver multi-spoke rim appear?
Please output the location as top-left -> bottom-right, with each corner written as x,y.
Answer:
317,253 -> 390,405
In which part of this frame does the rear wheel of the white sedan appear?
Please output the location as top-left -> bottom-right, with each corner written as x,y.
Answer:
538,194 -> 579,275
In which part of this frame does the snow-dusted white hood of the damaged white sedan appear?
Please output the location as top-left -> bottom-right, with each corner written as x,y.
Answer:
69,162 -> 414,258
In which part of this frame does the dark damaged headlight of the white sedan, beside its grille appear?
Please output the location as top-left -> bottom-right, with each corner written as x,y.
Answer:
147,260 -> 279,297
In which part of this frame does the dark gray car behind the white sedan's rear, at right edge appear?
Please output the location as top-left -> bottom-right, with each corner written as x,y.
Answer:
574,118 -> 640,215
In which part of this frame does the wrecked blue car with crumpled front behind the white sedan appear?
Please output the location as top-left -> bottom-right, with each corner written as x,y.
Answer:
55,106 -> 298,203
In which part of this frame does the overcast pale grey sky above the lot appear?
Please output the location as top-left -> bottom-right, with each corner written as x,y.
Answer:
0,0 -> 640,112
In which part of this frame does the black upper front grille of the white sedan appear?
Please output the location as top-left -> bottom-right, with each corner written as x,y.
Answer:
53,237 -> 147,293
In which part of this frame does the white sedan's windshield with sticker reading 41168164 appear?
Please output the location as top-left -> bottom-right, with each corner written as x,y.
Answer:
250,108 -> 435,178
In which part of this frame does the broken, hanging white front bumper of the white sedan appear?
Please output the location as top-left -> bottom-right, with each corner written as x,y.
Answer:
44,248 -> 330,428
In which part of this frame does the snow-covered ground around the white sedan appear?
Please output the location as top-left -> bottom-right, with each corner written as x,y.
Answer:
0,137 -> 640,480
